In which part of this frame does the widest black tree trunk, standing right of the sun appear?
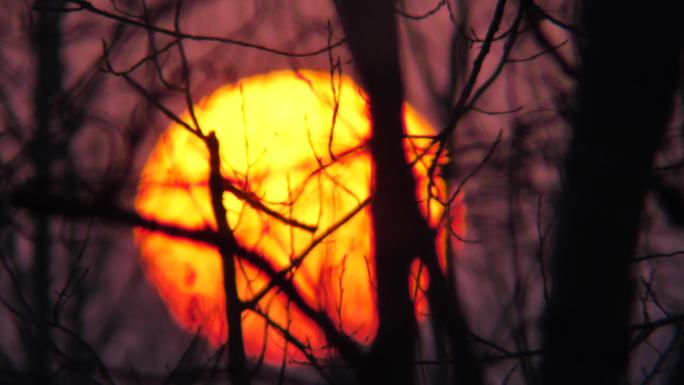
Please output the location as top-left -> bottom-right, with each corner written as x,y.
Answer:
541,1 -> 684,385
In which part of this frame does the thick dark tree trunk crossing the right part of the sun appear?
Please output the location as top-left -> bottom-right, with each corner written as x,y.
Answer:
338,0 -> 423,385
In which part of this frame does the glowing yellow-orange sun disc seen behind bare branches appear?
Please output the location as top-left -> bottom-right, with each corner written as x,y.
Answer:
135,71 -> 463,363
